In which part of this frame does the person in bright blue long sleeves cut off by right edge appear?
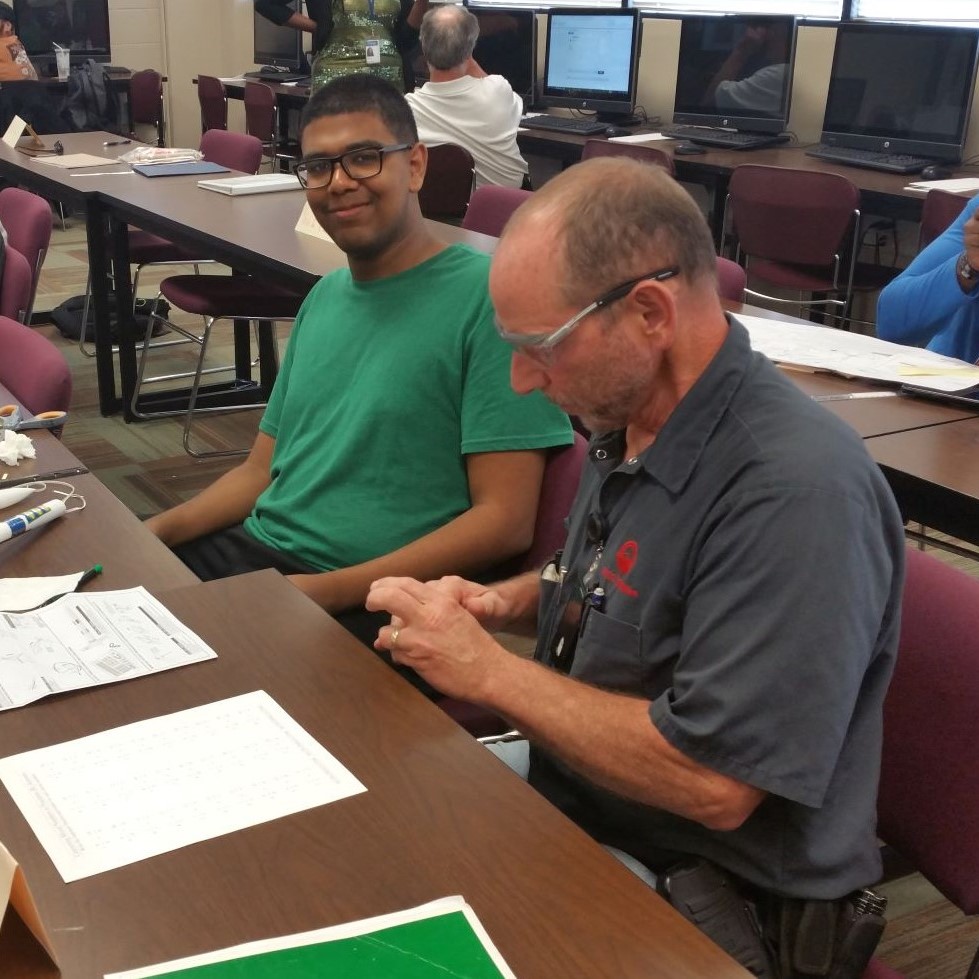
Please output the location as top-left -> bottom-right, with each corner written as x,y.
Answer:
877,197 -> 979,363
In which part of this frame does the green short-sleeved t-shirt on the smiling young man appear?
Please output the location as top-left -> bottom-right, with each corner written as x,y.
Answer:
245,245 -> 571,571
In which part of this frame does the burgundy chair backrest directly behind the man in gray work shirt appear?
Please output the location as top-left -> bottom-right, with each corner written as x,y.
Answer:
877,550 -> 979,914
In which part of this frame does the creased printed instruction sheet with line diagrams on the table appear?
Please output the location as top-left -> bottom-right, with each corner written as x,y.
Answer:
0,588 -> 217,710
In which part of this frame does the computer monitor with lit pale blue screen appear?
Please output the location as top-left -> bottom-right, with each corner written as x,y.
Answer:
538,8 -> 642,122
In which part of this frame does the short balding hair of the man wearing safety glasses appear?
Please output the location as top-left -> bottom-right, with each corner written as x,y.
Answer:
504,157 -> 717,304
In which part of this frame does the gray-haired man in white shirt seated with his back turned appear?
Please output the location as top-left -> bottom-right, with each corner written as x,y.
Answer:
406,4 -> 527,187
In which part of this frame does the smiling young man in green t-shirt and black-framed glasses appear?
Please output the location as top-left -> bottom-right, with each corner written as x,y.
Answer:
148,75 -> 571,641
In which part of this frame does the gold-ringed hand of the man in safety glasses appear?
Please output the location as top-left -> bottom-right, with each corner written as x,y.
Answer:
367,578 -> 510,703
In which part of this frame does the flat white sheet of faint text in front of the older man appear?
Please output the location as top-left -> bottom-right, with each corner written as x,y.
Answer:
0,691 -> 367,882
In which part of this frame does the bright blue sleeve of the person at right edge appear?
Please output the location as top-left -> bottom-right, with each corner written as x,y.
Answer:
877,197 -> 979,347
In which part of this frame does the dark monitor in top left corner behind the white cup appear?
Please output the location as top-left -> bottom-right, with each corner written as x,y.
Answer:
13,0 -> 112,75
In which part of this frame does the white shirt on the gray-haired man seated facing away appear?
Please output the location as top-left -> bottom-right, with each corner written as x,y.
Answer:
405,75 -> 527,187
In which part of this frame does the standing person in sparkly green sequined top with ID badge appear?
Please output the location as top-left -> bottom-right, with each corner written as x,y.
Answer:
255,0 -> 428,92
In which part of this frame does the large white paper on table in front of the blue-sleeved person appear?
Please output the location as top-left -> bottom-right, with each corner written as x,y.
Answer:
735,314 -> 979,391
